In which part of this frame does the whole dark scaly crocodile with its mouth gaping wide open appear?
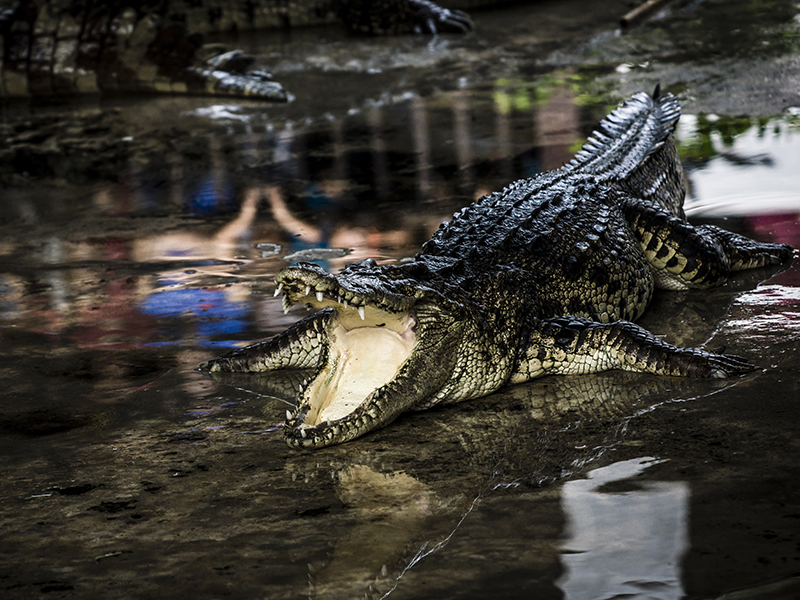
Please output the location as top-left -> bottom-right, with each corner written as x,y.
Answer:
205,86 -> 793,448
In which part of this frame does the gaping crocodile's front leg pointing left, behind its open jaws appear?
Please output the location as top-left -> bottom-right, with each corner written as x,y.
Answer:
200,309 -> 334,373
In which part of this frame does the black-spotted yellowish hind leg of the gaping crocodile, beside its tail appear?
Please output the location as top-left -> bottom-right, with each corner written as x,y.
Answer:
622,198 -> 792,290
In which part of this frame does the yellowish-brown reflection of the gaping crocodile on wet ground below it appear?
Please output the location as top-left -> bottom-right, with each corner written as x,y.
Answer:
247,373 -> 716,599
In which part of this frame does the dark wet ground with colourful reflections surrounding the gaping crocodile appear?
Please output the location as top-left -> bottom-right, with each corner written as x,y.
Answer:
0,0 -> 800,599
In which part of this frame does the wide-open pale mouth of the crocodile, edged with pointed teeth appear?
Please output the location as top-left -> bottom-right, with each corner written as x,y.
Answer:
276,271 -> 417,446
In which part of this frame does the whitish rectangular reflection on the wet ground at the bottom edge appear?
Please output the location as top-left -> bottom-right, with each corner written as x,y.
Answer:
558,458 -> 689,600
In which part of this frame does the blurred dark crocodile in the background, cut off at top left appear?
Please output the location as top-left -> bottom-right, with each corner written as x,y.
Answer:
0,0 -> 472,101
